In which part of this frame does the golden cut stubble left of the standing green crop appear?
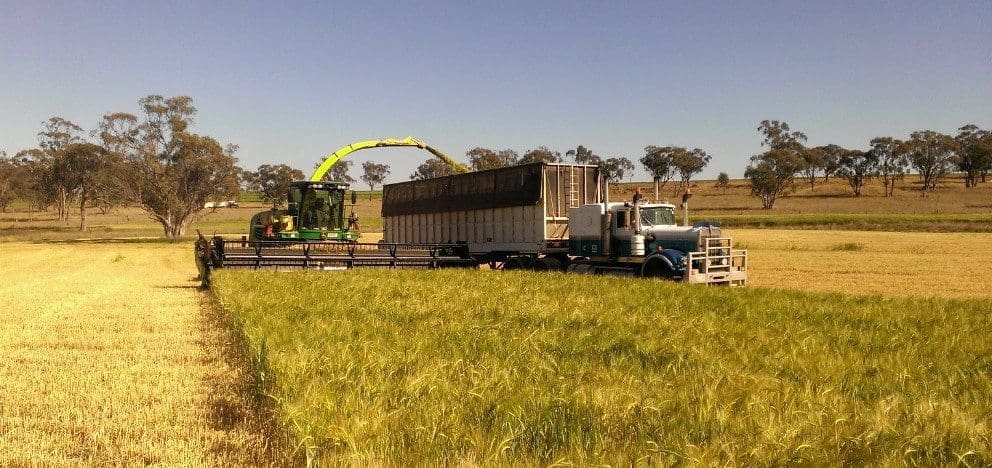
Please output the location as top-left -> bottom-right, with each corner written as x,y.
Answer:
0,243 -> 265,466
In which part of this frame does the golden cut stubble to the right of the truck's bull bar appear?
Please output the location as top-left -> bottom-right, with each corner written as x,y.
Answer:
727,229 -> 992,298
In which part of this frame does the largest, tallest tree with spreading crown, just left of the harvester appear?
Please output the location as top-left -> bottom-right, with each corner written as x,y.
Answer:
95,95 -> 239,237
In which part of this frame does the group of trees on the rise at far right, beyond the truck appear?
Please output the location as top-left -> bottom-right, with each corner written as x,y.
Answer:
744,120 -> 992,209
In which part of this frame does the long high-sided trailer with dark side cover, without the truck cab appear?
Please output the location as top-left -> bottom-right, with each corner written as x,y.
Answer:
382,163 -> 601,256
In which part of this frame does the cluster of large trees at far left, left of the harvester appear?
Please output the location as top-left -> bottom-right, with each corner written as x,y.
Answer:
0,95 -> 240,237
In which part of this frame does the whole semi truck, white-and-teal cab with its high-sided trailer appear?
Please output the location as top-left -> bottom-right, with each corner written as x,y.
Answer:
382,163 -> 747,286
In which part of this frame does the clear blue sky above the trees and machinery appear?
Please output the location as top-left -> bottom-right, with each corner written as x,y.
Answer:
0,0 -> 992,181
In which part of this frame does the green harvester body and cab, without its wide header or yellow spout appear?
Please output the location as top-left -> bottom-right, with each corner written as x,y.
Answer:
249,180 -> 359,242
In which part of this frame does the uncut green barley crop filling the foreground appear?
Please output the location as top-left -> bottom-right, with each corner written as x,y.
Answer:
214,270 -> 992,466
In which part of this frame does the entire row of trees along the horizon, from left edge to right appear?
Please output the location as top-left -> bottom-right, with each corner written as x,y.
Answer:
0,95 -> 992,237
